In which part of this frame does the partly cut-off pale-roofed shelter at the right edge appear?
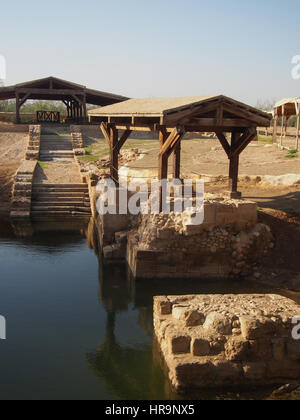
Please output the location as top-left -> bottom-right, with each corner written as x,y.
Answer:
273,98 -> 300,150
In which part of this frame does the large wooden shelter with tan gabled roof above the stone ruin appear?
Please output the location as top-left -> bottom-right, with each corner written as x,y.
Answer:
89,96 -> 272,207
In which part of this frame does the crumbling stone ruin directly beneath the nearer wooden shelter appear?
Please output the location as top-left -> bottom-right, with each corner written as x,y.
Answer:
127,195 -> 274,279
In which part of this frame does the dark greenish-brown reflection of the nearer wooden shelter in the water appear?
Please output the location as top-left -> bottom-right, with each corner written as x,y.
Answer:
87,261 -> 165,399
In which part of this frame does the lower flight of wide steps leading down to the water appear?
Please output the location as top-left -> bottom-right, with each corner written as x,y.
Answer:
31,184 -> 91,218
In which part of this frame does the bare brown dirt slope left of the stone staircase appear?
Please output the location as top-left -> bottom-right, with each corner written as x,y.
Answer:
0,124 -> 28,214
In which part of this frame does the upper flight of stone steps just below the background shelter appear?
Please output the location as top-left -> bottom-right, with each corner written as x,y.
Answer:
40,135 -> 74,162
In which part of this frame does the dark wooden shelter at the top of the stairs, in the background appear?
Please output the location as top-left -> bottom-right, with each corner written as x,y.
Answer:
0,77 -> 128,123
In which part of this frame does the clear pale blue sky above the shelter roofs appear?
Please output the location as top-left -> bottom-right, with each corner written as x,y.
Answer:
0,0 -> 300,105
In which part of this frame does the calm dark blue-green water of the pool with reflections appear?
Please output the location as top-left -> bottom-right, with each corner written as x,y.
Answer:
0,217 -> 296,400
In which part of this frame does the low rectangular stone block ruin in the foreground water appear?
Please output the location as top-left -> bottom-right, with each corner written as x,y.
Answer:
154,295 -> 300,391
